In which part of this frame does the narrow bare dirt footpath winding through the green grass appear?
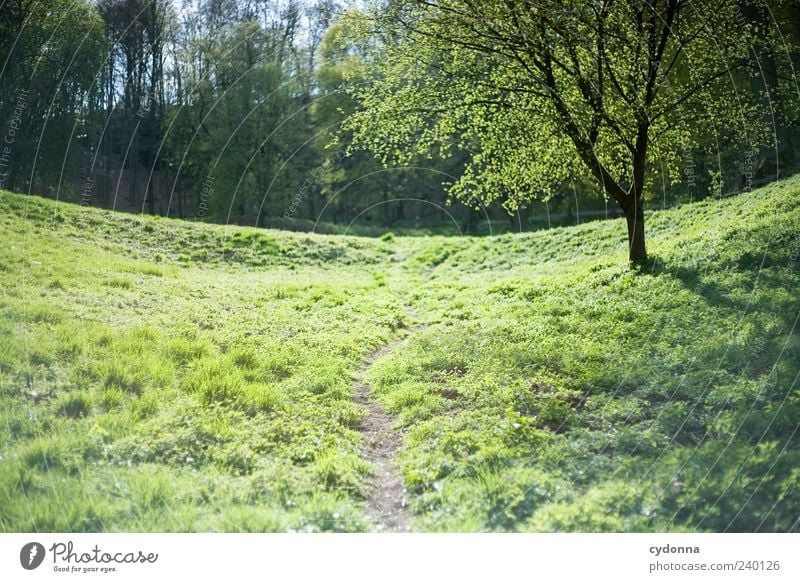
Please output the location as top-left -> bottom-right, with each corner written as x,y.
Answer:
353,326 -> 425,532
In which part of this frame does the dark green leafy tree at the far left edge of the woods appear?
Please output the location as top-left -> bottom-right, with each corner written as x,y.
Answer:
0,0 -> 105,195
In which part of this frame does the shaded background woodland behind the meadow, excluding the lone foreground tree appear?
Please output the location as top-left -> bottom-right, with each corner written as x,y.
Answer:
0,0 -> 800,231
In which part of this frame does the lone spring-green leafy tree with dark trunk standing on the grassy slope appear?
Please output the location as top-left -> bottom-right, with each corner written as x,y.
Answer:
348,0 -> 776,263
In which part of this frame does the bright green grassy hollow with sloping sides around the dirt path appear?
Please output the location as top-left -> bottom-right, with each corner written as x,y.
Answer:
0,179 -> 800,531
